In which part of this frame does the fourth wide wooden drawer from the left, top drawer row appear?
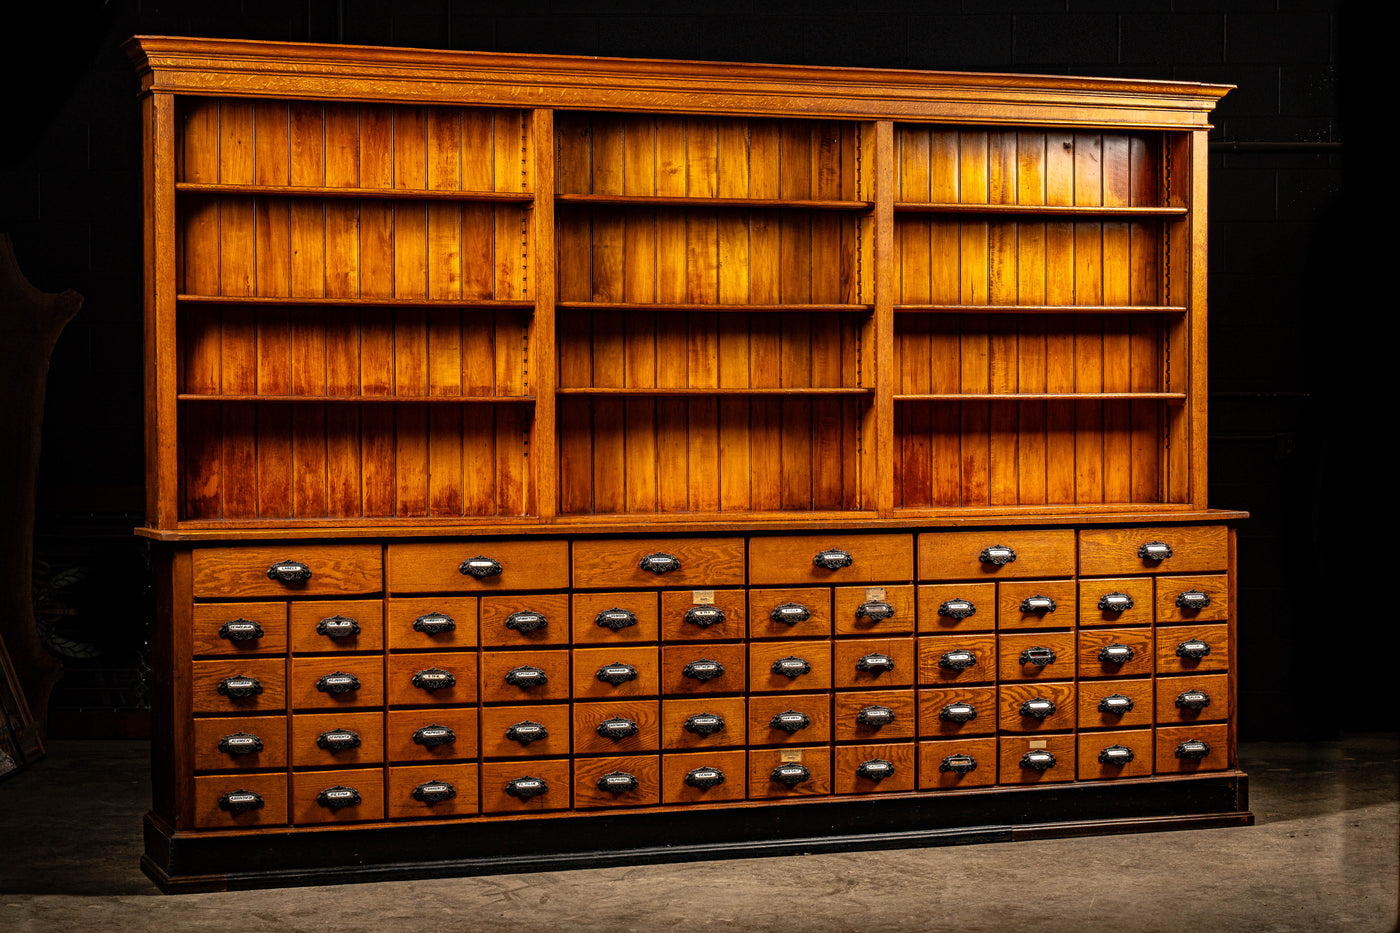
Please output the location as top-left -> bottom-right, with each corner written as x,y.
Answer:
749,535 -> 914,587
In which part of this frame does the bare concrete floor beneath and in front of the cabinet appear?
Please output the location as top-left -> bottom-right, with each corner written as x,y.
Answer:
0,734 -> 1400,933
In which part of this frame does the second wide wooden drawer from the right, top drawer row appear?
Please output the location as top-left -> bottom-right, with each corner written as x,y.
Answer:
918,528 -> 1074,580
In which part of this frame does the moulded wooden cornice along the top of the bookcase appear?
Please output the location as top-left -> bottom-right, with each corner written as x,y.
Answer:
126,36 -> 1232,129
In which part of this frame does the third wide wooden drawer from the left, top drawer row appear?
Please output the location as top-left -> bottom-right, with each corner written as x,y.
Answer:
574,538 -> 743,590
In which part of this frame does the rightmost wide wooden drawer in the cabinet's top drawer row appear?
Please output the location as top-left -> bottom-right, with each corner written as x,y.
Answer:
1079,525 -> 1229,577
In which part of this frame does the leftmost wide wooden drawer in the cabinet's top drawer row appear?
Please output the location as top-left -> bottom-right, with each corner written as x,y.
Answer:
192,541 -> 384,600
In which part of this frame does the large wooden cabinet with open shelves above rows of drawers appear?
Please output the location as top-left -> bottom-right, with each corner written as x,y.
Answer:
129,38 -> 1250,888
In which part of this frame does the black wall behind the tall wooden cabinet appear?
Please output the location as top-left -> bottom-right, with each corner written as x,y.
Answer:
0,0 -> 1355,741
